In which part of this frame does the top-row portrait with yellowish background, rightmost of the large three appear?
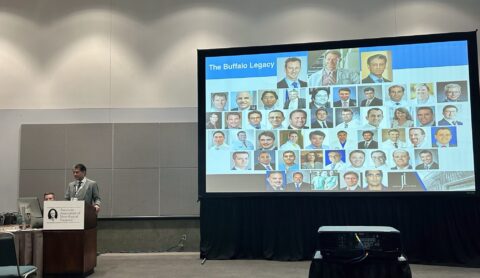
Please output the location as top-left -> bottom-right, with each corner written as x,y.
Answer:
361,51 -> 393,83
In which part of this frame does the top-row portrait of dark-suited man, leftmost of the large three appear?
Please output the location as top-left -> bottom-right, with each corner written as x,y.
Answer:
277,57 -> 308,89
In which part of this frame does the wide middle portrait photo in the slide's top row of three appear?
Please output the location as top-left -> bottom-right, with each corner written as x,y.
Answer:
308,48 -> 360,87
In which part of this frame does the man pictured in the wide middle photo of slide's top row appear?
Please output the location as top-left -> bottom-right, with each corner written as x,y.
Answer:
308,50 -> 360,87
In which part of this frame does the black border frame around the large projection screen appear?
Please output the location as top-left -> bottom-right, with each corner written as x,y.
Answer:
197,31 -> 480,199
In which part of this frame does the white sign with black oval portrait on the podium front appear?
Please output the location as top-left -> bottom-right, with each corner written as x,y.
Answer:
43,201 -> 85,230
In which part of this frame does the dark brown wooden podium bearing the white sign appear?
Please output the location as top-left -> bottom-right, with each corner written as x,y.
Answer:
43,202 -> 97,277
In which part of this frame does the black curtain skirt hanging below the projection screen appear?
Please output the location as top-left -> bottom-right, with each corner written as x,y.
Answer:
200,196 -> 480,267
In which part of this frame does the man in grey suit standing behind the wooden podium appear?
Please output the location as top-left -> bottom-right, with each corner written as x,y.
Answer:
65,163 -> 101,213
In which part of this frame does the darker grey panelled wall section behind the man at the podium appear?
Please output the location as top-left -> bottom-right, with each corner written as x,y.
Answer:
20,123 -> 199,218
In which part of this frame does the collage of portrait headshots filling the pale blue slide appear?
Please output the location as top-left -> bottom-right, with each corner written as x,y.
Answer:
205,48 -> 474,192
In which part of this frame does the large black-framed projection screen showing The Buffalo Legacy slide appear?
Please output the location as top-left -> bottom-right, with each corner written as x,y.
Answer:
198,33 -> 478,196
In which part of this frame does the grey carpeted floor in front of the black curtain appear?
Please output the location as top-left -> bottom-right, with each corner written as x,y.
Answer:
89,252 -> 480,278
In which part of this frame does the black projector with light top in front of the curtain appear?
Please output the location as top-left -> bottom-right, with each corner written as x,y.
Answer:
316,226 -> 403,263
